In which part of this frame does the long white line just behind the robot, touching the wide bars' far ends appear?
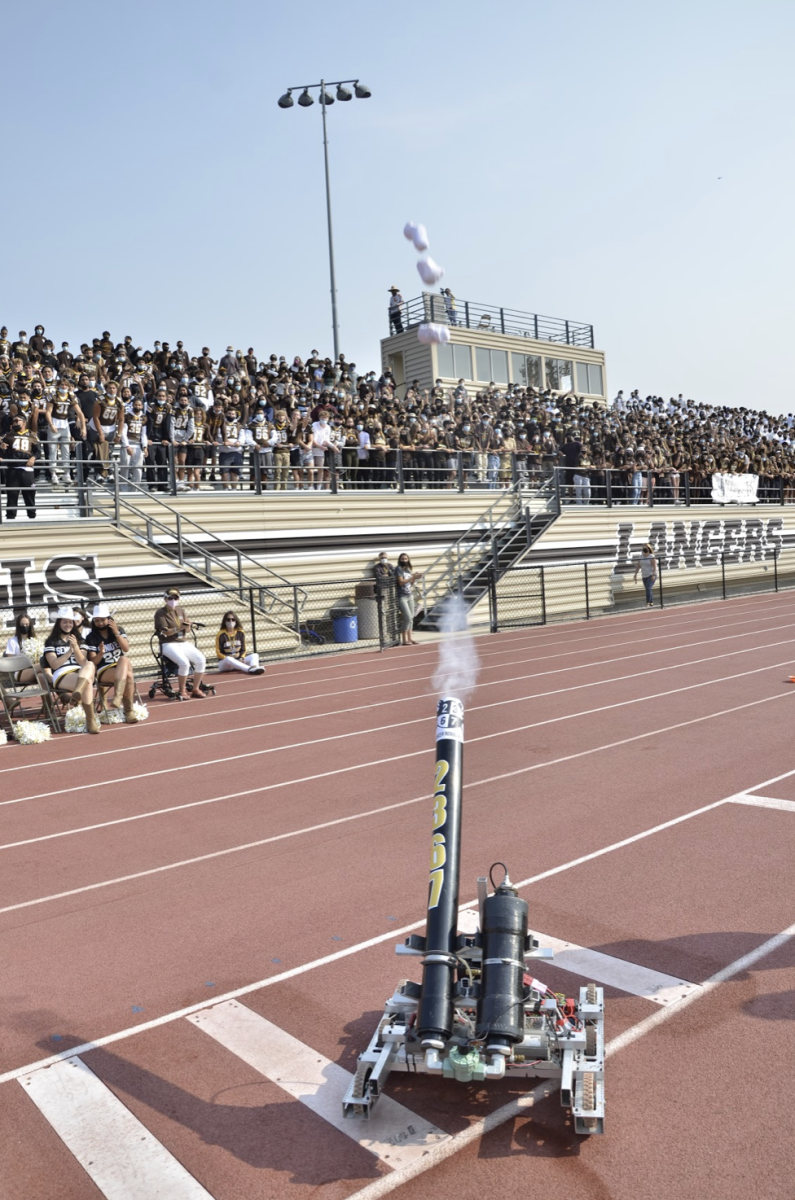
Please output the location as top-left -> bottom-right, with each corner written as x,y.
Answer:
0,787 -> 764,1084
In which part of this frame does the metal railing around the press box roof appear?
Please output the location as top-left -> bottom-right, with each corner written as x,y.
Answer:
390,292 -> 593,349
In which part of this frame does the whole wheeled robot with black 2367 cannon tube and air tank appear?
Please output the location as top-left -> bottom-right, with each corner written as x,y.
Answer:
342,697 -> 604,1135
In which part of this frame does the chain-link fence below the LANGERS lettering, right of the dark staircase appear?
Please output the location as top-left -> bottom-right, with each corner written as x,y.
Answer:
489,550 -> 795,634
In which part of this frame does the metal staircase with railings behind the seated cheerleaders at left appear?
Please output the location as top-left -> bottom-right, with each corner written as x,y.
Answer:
89,463 -> 306,644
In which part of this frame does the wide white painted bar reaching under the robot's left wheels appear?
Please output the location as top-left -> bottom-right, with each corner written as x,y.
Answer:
187,1000 -> 449,1169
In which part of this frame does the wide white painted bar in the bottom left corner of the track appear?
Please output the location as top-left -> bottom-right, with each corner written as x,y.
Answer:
19,1058 -> 213,1200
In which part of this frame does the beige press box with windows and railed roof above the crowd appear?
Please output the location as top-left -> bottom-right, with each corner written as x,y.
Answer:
381,292 -> 608,404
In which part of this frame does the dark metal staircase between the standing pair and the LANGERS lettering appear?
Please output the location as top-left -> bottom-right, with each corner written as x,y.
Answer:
416,480 -> 561,630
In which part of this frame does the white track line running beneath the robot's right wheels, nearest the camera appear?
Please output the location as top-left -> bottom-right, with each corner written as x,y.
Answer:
348,925 -> 795,1200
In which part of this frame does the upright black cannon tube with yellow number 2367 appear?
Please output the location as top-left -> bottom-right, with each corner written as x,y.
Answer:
417,696 -> 464,1050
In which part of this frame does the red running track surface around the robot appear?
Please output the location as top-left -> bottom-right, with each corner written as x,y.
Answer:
0,596 -> 795,1200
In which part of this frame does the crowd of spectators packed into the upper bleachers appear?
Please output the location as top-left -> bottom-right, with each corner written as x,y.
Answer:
0,325 -> 795,517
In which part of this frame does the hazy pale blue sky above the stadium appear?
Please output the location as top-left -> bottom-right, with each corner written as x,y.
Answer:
0,0 -> 795,412
